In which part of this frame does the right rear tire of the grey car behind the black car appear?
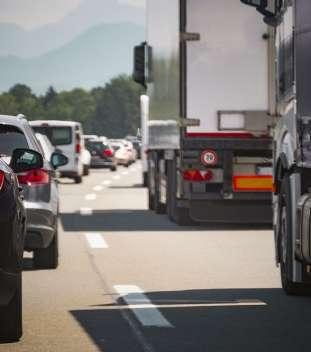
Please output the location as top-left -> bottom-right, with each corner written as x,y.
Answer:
33,231 -> 58,269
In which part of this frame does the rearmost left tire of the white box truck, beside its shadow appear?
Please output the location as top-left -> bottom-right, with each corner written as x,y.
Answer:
166,160 -> 195,226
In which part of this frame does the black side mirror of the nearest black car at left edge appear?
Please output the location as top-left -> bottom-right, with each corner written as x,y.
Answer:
10,149 -> 43,173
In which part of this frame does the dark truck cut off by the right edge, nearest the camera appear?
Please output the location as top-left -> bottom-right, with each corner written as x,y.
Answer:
242,0 -> 311,294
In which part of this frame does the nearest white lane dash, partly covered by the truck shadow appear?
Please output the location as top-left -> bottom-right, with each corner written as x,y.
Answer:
114,285 -> 173,328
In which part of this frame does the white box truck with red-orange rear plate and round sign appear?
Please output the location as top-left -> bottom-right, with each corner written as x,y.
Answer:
133,0 -> 273,225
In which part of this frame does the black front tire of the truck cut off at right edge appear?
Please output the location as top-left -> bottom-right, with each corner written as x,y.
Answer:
278,175 -> 311,295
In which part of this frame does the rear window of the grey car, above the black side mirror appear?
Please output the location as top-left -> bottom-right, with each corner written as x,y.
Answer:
0,125 -> 29,156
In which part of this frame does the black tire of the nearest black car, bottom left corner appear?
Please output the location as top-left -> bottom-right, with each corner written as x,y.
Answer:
0,273 -> 22,343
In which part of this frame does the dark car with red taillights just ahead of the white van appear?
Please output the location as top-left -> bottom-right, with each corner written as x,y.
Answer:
85,140 -> 118,171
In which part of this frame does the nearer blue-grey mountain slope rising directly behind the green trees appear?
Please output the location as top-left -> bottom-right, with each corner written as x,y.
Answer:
0,22 -> 144,94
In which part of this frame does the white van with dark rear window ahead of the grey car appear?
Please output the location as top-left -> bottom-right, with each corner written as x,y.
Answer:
30,120 -> 85,183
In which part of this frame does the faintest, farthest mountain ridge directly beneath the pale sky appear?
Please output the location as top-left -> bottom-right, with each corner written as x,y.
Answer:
0,0 -> 144,58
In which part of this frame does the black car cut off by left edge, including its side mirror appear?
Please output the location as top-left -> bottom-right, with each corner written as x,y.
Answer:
0,149 -> 43,342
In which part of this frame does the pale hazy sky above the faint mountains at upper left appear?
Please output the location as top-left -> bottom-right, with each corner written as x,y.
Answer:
0,0 -> 145,29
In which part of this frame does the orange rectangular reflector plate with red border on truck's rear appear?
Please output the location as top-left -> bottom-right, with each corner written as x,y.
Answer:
233,175 -> 272,192
